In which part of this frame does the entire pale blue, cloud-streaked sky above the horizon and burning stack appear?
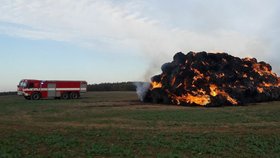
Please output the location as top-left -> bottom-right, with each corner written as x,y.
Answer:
0,0 -> 280,91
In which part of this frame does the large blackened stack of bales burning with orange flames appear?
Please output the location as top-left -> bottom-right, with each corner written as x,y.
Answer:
143,52 -> 280,107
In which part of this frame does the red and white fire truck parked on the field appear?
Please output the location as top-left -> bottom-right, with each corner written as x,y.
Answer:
17,79 -> 87,100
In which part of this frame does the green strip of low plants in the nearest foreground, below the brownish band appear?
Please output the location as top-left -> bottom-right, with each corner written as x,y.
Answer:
0,128 -> 280,157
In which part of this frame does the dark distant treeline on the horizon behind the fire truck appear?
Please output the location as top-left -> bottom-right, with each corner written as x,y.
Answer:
0,82 -> 142,96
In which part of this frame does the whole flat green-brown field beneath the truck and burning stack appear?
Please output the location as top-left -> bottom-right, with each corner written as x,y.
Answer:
0,92 -> 280,158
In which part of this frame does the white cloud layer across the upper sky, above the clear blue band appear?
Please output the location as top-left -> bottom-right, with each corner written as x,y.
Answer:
0,0 -> 280,79
